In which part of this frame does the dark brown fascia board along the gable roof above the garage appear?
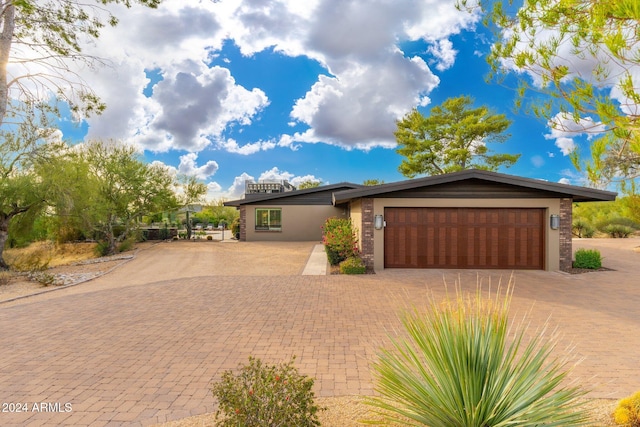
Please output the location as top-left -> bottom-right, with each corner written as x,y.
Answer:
333,169 -> 618,205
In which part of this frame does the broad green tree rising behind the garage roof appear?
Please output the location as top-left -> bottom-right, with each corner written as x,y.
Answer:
394,96 -> 520,178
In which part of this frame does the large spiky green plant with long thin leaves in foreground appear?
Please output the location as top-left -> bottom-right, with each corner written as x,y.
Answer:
366,284 -> 589,427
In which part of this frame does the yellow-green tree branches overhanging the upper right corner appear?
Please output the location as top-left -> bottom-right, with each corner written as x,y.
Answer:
458,0 -> 640,183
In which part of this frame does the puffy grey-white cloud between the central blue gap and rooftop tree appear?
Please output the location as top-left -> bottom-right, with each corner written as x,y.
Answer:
291,52 -> 439,149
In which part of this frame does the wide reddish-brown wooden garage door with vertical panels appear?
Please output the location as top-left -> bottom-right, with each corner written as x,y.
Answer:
384,208 -> 544,269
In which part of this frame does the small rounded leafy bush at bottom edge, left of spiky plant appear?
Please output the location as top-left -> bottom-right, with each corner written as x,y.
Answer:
212,357 -> 320,427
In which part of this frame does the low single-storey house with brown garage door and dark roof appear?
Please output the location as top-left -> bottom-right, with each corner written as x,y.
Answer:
227,170 -> 616,271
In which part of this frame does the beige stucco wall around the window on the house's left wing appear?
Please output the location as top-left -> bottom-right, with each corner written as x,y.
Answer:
246,205 -> 346,242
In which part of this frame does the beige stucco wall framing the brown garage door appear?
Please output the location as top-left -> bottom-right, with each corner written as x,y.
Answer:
368,198 -> 560,271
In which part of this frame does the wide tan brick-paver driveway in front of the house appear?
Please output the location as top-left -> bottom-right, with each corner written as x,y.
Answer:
0,240 -> 640,426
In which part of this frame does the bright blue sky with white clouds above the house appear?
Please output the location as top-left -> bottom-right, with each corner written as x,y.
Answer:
48,0 -> 600,199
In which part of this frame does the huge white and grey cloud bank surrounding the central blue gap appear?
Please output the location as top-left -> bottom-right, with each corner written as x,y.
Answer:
71,0 -> 478,155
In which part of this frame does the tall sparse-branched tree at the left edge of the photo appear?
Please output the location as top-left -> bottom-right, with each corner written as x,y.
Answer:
0,0 -> 161,268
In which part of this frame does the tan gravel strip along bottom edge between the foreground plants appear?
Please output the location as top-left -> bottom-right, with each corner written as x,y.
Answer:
152,396 -> 617,427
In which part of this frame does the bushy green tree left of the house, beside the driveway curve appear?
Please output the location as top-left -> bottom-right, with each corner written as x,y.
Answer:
76,141 -> 178,255
